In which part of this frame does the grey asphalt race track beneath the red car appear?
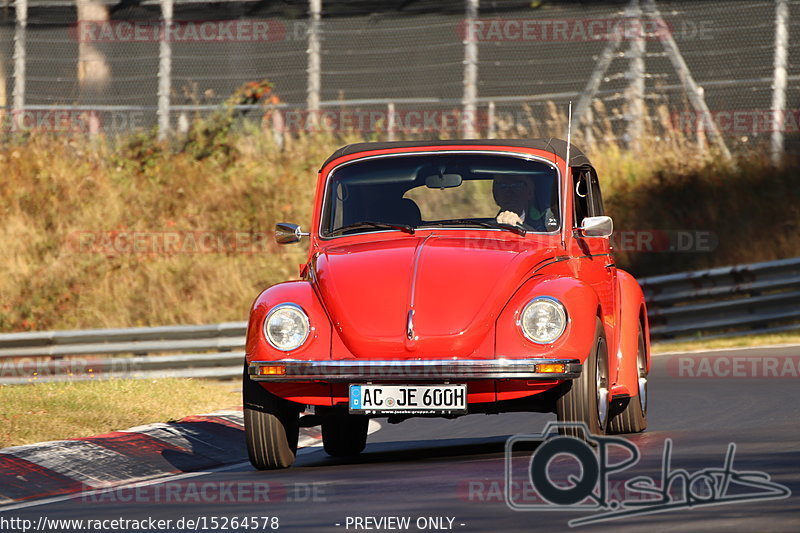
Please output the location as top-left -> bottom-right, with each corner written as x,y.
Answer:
6,347 -> 800,532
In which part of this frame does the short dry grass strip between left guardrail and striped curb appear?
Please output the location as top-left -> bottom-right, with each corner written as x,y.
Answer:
0,379 -> 241,448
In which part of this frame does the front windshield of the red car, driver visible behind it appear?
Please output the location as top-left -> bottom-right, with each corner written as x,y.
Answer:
321,153 -> 560,237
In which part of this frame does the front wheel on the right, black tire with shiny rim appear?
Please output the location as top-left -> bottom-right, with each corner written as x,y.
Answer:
556,318 -> 609,438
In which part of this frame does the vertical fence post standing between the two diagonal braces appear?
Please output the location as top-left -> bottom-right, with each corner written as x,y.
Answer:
626,0 -> 645,150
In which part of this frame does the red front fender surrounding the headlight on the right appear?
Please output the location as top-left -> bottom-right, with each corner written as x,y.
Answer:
495,275 -> 598,362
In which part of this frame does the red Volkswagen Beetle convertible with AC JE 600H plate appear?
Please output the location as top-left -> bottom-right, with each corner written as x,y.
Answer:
243,139 -> 650,469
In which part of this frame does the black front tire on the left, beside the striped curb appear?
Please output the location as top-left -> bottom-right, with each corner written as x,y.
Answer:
242,364 -> 301,470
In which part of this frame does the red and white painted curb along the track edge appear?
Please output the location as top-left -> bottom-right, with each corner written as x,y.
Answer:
0,410 -> 380,504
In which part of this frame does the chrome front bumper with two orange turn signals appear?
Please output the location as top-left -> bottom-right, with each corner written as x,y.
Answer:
248,359 -> 582,382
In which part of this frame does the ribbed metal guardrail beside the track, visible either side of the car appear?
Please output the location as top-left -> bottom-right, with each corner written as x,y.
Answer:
0,258 -> 800,384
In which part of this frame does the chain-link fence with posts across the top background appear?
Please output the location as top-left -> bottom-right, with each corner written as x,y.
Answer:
0,0 -> 800,156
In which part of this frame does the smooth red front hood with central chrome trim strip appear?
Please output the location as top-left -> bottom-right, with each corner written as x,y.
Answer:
314,234 -> 555,359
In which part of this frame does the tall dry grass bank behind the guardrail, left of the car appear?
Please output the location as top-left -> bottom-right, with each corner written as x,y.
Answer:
0,128 -> 333,331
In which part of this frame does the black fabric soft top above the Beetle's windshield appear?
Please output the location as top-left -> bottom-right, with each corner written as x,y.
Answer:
322,138 -> 592,168
